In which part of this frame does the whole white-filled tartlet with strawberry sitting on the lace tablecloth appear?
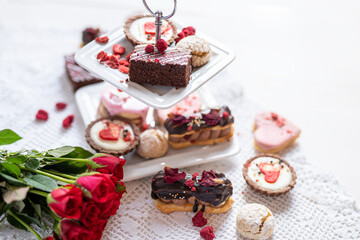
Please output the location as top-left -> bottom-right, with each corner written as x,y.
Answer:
243,154 -> 296,196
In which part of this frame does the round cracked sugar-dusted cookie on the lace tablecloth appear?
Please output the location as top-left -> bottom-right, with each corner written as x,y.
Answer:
236,203 -> 275,239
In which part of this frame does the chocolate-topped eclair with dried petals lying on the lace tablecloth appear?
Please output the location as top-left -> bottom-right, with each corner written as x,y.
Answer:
151,166 -> 234,213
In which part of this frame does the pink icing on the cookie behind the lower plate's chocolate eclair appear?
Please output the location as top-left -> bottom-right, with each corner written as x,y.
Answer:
158,93 -> 202,122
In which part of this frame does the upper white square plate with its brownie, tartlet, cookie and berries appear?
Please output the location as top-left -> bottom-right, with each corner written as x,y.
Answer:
75,2 -> 235,109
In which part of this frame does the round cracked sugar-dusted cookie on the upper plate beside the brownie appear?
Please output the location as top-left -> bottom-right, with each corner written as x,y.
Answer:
176,36 -> 211,67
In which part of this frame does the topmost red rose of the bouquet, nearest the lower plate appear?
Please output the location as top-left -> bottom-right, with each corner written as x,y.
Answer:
93,155 -> 126,179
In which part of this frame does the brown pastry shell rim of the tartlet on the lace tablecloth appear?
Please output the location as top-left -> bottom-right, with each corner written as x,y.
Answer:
243,154 -> 297,196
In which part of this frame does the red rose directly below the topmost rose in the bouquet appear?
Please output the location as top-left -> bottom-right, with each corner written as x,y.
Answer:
76,174 -> 116,203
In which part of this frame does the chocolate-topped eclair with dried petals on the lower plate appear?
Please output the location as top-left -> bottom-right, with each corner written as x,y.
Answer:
164,106 -> 234,148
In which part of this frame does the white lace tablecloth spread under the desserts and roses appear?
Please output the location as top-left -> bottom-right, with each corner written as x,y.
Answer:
0,25 -> 360,240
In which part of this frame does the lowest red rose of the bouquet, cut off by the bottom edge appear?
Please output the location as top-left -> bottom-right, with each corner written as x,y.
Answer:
59,219 -> 94,240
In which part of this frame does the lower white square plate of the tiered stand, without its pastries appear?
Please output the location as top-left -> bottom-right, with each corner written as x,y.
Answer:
75,83 -> 240,181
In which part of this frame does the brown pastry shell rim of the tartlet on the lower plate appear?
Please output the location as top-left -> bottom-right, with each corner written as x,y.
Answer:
85,116 -> 140,156
